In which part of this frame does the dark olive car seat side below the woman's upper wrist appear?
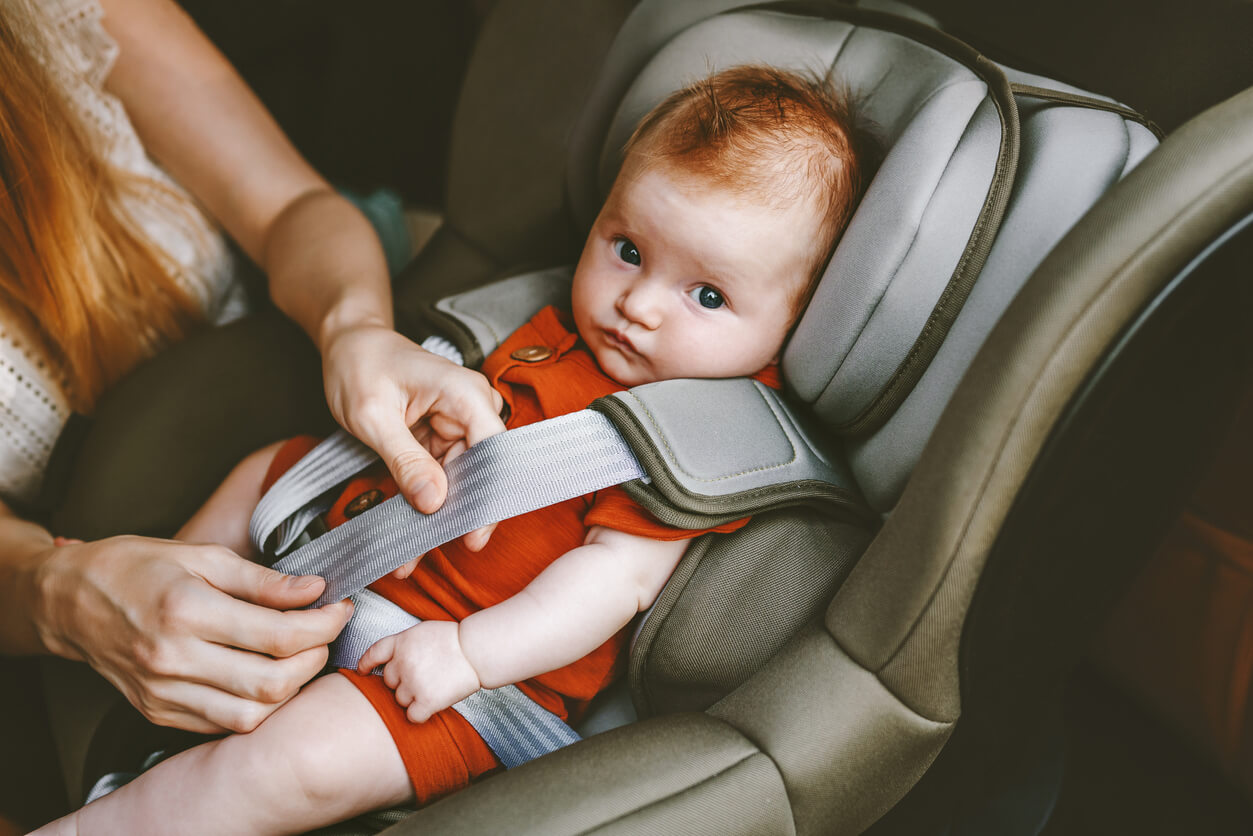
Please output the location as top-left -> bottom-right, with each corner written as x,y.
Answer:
53,312 -> 333,540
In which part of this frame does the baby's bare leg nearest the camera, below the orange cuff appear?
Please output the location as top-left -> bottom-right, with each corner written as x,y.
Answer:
40,674 -> 412,833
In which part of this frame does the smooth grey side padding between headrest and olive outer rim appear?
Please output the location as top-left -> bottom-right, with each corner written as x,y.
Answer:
846,99 -> 1155,511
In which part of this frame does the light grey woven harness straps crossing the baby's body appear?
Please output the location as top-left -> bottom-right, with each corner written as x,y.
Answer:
249,410 -> 647,768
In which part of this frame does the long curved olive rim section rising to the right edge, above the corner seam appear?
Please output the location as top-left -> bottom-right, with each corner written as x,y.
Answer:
826,90 -> 1253,721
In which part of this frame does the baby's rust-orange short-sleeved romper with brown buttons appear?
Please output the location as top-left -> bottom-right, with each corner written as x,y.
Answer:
260,307 -> 779,805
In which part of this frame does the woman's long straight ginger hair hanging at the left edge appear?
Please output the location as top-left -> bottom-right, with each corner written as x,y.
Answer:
0,0 -> 203,412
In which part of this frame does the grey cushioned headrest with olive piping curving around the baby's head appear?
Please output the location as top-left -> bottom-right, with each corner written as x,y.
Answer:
571,0 -> 1002,438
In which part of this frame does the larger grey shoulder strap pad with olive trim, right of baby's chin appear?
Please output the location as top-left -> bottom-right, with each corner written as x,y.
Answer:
598,377 -> 857,514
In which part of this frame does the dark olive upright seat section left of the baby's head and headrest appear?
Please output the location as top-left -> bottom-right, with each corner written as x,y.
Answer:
446,0 -> 634,266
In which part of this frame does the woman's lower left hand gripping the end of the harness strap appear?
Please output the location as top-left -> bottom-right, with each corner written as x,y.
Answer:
35,536 -> 352,733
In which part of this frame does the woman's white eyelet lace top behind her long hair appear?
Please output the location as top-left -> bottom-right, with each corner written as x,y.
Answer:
0,0 -> 244,501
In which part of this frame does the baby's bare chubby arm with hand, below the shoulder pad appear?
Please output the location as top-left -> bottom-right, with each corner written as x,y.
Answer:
357,526 -> 688,723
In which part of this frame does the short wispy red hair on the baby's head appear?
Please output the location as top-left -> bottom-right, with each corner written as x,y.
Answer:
624,65 -> 878,305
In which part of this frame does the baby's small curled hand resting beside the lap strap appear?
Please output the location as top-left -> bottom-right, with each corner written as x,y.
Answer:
357,622 -> 480,723
